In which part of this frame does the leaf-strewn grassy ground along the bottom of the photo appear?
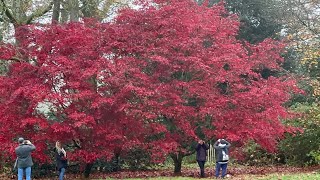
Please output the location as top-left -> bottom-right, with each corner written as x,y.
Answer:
0,163 -> 320,180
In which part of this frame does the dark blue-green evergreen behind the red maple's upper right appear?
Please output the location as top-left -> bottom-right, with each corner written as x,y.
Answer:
197,0 -> 284,43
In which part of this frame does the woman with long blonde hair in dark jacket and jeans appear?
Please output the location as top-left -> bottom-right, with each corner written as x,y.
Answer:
55,141 -> 68,180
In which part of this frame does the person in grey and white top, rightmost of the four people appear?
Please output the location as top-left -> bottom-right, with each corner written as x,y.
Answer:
213,139 -> 231,178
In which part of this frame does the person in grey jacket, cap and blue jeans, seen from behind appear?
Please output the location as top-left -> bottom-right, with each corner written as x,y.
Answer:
15,138 -> 36,180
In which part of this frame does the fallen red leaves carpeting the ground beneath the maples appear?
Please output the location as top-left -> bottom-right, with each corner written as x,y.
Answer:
0,166 -> 320,180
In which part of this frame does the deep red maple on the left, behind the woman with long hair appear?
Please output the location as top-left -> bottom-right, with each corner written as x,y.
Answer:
0,23 -> 155,174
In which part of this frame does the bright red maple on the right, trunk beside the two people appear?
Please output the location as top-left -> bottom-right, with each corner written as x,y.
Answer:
109,0 -> 301,172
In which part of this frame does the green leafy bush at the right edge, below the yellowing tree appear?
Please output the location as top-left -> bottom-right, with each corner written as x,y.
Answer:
279,104 -> 320,165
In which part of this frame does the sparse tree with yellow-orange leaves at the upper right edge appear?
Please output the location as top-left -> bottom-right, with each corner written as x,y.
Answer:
283,0 -> 320,86
